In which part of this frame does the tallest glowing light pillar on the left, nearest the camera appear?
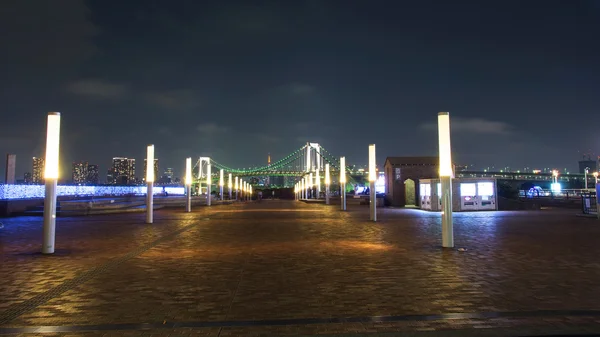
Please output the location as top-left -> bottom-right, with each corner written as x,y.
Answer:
42,112 -> 60,254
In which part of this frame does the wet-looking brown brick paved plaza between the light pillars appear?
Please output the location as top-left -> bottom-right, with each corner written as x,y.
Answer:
0,201 -> 600,336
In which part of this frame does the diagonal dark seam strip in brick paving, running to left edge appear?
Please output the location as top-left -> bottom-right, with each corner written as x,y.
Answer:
0,221 -> 199,326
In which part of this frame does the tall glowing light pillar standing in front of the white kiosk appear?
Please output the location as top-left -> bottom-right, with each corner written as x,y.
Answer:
438,112 -> 454,248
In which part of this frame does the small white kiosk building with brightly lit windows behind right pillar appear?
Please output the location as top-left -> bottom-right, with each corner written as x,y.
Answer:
419,178 -> 498,212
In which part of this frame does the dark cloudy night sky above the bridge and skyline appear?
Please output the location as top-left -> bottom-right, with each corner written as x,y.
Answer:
0,0 -> 600,180
